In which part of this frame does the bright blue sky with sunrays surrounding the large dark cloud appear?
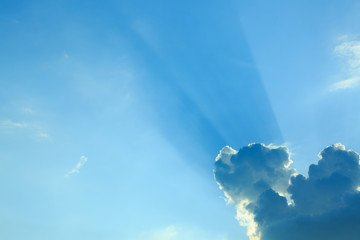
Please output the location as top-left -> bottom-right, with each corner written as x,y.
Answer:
0,1 -> 360,240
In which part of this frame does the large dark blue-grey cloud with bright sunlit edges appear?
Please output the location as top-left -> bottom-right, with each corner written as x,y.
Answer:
214,143 -> 360,240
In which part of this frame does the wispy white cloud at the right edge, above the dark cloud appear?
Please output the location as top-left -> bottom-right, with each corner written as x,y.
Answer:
330,35 -> 360,91
